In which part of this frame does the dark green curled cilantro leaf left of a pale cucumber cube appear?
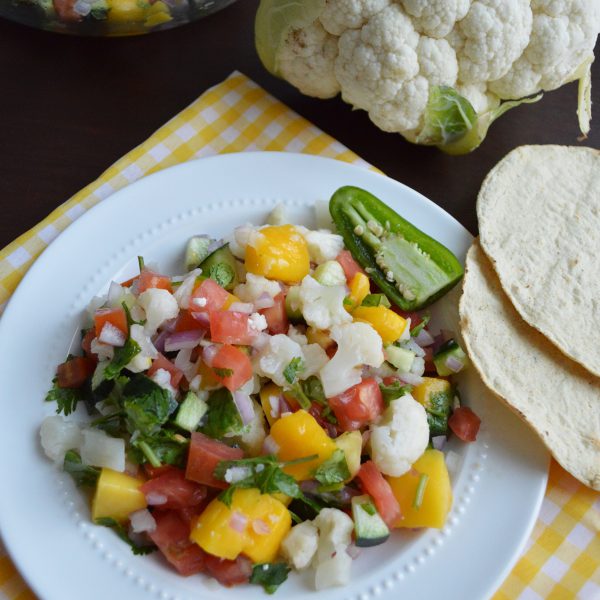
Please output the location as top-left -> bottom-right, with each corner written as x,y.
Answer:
123,374 -> 177,436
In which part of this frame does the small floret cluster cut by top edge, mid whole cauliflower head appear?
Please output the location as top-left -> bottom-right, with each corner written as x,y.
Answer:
401,0 -> 471,38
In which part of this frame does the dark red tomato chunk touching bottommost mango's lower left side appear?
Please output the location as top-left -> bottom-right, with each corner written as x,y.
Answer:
148,510 -> 207,576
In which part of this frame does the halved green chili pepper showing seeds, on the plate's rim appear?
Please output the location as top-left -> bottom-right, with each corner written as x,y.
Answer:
329,186 -> 463,311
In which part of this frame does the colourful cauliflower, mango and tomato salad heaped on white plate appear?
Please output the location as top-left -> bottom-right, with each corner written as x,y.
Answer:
40,187 -> 480,593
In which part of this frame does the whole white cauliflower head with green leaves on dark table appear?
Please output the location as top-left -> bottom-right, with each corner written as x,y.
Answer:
256,0 -> 600,153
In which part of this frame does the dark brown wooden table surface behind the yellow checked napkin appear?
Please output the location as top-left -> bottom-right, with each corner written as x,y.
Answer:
0,0 -> 600,247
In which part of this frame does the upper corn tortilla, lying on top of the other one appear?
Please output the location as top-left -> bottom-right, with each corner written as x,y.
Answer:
477,146 -> 600,376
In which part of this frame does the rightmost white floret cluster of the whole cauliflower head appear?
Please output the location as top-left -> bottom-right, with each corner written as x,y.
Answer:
489,0 -> 600,99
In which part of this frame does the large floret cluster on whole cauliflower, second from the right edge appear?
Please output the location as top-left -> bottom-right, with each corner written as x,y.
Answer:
450,0 -> 533,83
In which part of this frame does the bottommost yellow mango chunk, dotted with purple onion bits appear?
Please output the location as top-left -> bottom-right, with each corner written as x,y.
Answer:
190,488 -> 292,562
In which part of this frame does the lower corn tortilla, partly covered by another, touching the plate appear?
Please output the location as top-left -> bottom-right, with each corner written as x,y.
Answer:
459,241 -> 600,490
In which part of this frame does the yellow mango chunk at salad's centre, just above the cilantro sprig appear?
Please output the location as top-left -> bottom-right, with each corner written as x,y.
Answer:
271,410 -> 336,481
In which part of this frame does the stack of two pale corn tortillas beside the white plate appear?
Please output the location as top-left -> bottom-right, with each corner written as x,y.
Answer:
460,146 -> 600,490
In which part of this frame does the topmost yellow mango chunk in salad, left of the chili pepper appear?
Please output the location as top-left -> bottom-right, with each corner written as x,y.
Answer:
246,225 -> 310,284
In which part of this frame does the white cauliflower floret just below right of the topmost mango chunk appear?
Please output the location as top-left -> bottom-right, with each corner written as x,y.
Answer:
298,275 -> 352,329
